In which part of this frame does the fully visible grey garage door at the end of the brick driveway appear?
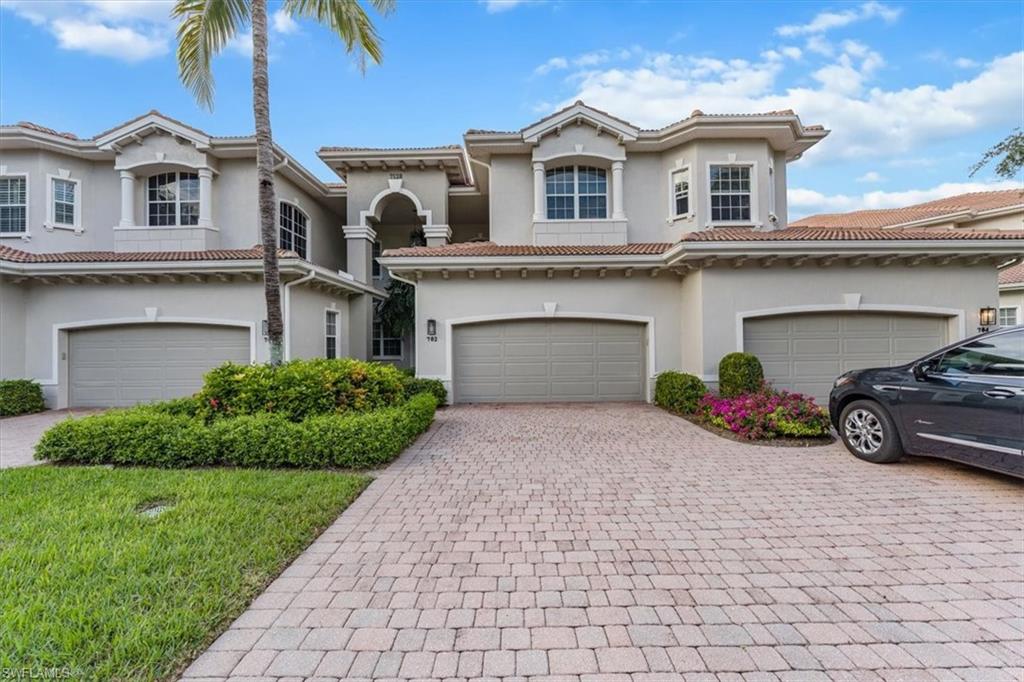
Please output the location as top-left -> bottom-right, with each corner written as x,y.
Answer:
453,319 -> 645,402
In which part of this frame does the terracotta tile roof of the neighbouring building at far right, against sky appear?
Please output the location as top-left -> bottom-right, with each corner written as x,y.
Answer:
790,189 -> 1024,228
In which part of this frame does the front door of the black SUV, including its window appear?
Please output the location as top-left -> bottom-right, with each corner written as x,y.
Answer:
900,331 -> 1024,471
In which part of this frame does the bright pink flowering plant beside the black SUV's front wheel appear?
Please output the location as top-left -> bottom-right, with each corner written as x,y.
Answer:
697,386 -> 828,440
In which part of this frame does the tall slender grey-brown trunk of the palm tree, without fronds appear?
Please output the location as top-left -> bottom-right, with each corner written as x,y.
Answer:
246,0 -> 285,365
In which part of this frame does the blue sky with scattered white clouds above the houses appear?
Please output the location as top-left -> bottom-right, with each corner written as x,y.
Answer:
0,0 -> 1024,217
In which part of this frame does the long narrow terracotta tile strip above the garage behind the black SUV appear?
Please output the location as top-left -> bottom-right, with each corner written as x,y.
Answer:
683,227 -> 1024,242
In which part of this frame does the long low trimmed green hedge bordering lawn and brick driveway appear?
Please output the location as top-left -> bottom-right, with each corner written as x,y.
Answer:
36,393 -> 437,469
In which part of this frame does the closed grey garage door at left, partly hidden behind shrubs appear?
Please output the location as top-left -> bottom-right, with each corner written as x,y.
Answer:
68,325 -> 249,407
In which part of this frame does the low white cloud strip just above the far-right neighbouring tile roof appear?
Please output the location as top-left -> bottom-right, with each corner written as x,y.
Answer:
786,180 -> 1022,215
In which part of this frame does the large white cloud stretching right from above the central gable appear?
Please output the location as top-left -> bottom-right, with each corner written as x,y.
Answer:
556,47 -> 1024,161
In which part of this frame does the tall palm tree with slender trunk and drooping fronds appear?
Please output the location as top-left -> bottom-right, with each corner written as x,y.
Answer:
171,0 -> 394,365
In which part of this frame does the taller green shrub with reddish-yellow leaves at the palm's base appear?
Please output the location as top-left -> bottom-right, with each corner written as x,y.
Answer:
199,357 -> 406,422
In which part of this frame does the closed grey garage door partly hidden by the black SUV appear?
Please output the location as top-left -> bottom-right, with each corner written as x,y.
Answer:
743,312 -> 947,404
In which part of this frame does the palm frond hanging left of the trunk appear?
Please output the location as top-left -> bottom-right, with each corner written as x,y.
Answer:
171,0 -> 249,110
